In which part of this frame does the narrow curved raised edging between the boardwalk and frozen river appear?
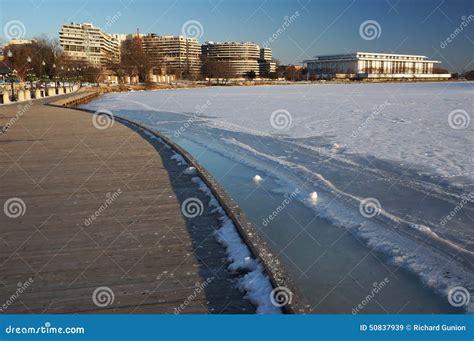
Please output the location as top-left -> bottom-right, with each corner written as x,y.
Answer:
47,90 -> 311,314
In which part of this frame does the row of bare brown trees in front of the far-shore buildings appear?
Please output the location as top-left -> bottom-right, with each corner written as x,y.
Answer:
0,37 -> 314,82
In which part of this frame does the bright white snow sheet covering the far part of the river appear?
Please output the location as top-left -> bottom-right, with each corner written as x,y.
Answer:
87,83 -> 474,186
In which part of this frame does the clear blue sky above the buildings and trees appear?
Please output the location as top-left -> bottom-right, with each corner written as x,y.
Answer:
0,0 -> 474,71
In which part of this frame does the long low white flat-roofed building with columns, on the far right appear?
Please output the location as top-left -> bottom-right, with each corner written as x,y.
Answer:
304,52 -> 451,79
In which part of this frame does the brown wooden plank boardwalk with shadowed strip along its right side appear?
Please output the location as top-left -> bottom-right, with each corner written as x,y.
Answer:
0,96 -> 255,314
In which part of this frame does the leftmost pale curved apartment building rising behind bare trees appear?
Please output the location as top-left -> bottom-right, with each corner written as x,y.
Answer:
59,23 -> 120,67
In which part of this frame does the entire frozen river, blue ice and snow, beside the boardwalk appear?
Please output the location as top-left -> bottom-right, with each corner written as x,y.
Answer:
86,83 -> 474,313
